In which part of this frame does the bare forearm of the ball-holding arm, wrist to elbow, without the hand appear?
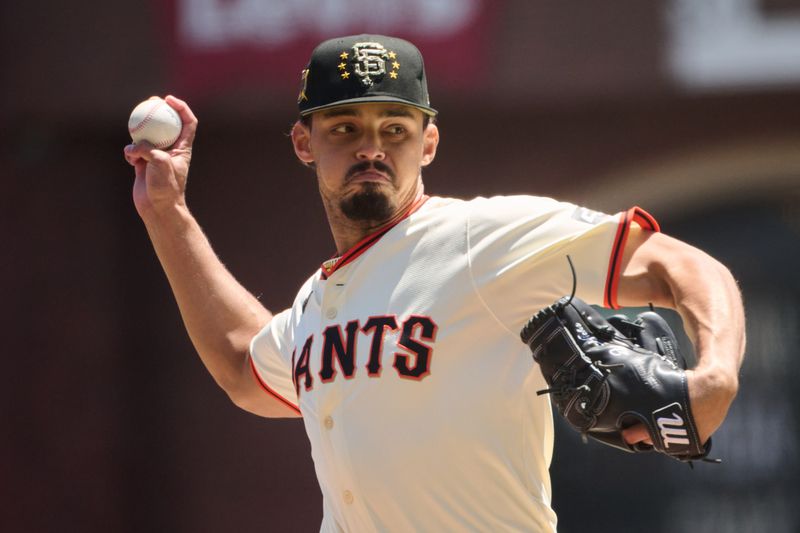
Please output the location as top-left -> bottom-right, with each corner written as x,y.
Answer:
143,206 -> 272,394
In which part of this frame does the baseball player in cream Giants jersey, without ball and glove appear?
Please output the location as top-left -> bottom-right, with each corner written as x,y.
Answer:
125,35 -> 744,532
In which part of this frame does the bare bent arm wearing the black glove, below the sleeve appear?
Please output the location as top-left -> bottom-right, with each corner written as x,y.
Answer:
617,227 -> 745,442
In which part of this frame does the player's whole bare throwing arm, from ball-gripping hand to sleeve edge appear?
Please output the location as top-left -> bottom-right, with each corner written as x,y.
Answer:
125,97 -> 297,417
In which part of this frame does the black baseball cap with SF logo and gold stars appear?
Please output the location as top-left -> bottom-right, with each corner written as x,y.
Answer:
297,34 -> 437,116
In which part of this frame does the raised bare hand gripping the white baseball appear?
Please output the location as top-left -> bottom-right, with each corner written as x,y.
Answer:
124,95 -> 202,218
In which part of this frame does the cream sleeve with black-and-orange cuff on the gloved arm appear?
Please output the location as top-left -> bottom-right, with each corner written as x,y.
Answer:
467,196 -> 659,329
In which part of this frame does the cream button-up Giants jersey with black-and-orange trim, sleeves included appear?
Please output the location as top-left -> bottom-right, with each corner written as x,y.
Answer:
251,196 -> 658,532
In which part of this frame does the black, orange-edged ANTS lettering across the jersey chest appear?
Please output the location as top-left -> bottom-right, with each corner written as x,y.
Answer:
292,315 -> 437,397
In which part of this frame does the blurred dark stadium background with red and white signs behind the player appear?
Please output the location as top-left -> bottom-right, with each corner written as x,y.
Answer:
0,0 -> 800,533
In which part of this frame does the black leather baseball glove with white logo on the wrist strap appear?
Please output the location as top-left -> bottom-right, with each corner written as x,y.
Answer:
520,297 -> 711,461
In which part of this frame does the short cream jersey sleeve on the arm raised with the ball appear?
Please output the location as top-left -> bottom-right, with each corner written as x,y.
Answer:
250,309 -> 300,413
